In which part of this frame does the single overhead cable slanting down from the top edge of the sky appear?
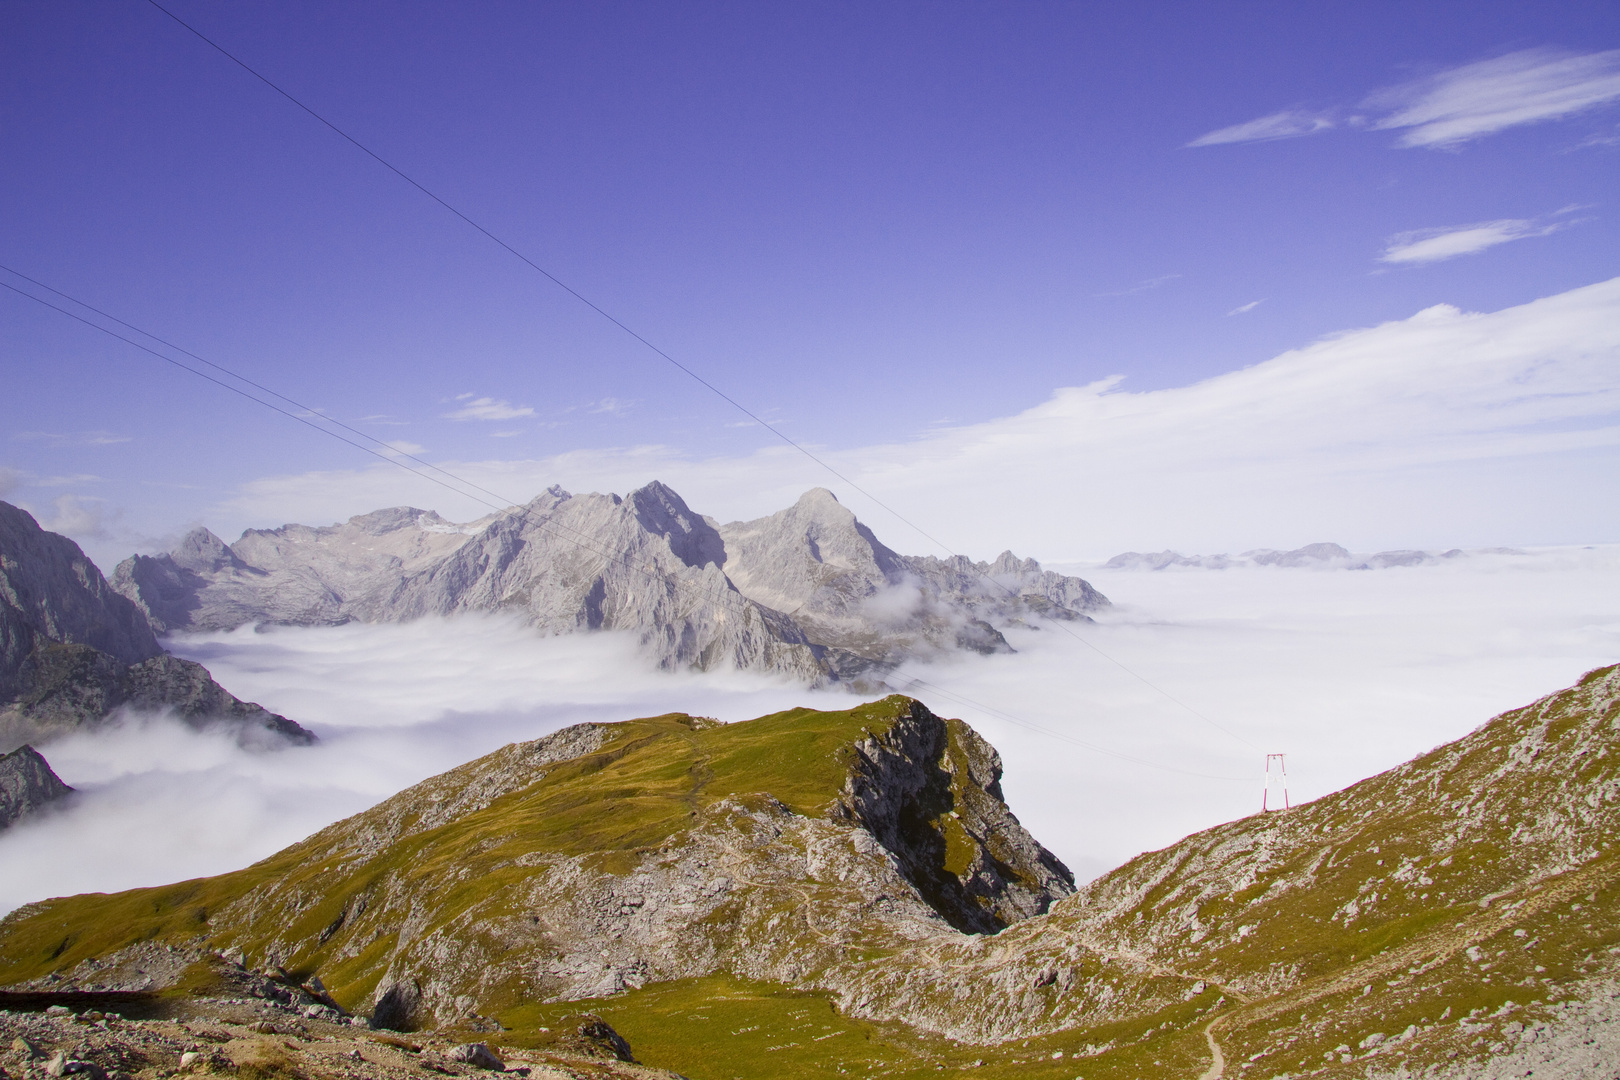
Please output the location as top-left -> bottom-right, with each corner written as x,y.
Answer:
146,0 -> 1259,750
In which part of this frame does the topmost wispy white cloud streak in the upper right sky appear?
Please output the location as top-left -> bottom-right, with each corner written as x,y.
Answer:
1187,49 -> 1620,149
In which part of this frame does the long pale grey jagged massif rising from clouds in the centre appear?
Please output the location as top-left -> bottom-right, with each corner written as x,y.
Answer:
113,481 -> 1108,683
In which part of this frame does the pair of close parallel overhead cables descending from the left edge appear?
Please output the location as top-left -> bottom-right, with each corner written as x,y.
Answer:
0,264 -> 1254,782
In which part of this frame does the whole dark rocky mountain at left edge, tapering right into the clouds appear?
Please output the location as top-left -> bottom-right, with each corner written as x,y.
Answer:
0,502 -> 314,751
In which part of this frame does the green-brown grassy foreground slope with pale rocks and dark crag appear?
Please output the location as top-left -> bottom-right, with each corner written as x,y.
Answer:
0,667 -> 1620,1078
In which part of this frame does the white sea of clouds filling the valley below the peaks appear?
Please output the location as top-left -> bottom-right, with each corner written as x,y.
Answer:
0,546 -> 1620,910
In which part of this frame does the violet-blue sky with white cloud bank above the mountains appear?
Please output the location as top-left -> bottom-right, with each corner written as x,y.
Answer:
0,0 -> 1620,563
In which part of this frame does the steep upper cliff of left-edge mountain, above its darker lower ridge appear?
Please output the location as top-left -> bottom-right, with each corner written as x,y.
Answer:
0,502 -> 164,703
